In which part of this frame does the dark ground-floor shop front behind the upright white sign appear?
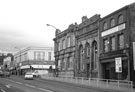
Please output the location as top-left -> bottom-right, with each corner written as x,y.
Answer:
102,57 -> 128,80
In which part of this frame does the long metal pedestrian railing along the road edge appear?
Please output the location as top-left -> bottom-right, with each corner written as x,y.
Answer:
41,75 -> 134,92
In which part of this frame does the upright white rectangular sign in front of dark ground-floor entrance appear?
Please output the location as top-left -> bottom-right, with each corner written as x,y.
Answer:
115,57 -> 122,73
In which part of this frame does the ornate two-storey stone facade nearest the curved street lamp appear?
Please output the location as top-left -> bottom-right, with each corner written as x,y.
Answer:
54,24 -> 76,77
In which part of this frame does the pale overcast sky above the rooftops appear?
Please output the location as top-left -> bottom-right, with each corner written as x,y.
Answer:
0,0 -> 134,52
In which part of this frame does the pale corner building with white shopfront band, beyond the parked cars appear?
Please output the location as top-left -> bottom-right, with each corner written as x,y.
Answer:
14,47 -> 55,74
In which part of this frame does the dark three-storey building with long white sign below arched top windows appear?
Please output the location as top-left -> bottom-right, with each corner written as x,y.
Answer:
99,3 -> 135,80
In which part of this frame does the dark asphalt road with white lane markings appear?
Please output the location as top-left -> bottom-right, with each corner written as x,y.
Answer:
0,76 -> 116,92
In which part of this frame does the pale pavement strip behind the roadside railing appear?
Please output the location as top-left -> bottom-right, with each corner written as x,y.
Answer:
41,75 -> 135,92
